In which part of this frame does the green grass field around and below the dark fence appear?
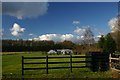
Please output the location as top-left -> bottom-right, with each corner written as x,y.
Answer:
2,52 -> 112,78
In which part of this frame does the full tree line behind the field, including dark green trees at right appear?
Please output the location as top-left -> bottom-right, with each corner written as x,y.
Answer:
2,33 -> 119,53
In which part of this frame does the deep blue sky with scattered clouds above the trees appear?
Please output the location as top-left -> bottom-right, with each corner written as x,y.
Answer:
0,2 -> 118,42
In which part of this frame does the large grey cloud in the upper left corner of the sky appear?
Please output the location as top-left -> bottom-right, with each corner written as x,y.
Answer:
2,2 -> 48,19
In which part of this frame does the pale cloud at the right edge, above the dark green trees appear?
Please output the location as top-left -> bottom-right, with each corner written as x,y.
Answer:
108,18 -> 120,32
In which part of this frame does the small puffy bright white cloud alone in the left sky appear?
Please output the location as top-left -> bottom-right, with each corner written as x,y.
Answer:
10,23 -> 25,37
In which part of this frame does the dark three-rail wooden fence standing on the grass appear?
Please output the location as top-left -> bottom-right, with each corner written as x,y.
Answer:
22,55 -> 91,75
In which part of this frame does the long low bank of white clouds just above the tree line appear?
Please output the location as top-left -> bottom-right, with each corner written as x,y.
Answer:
30,27 -> 93,43
